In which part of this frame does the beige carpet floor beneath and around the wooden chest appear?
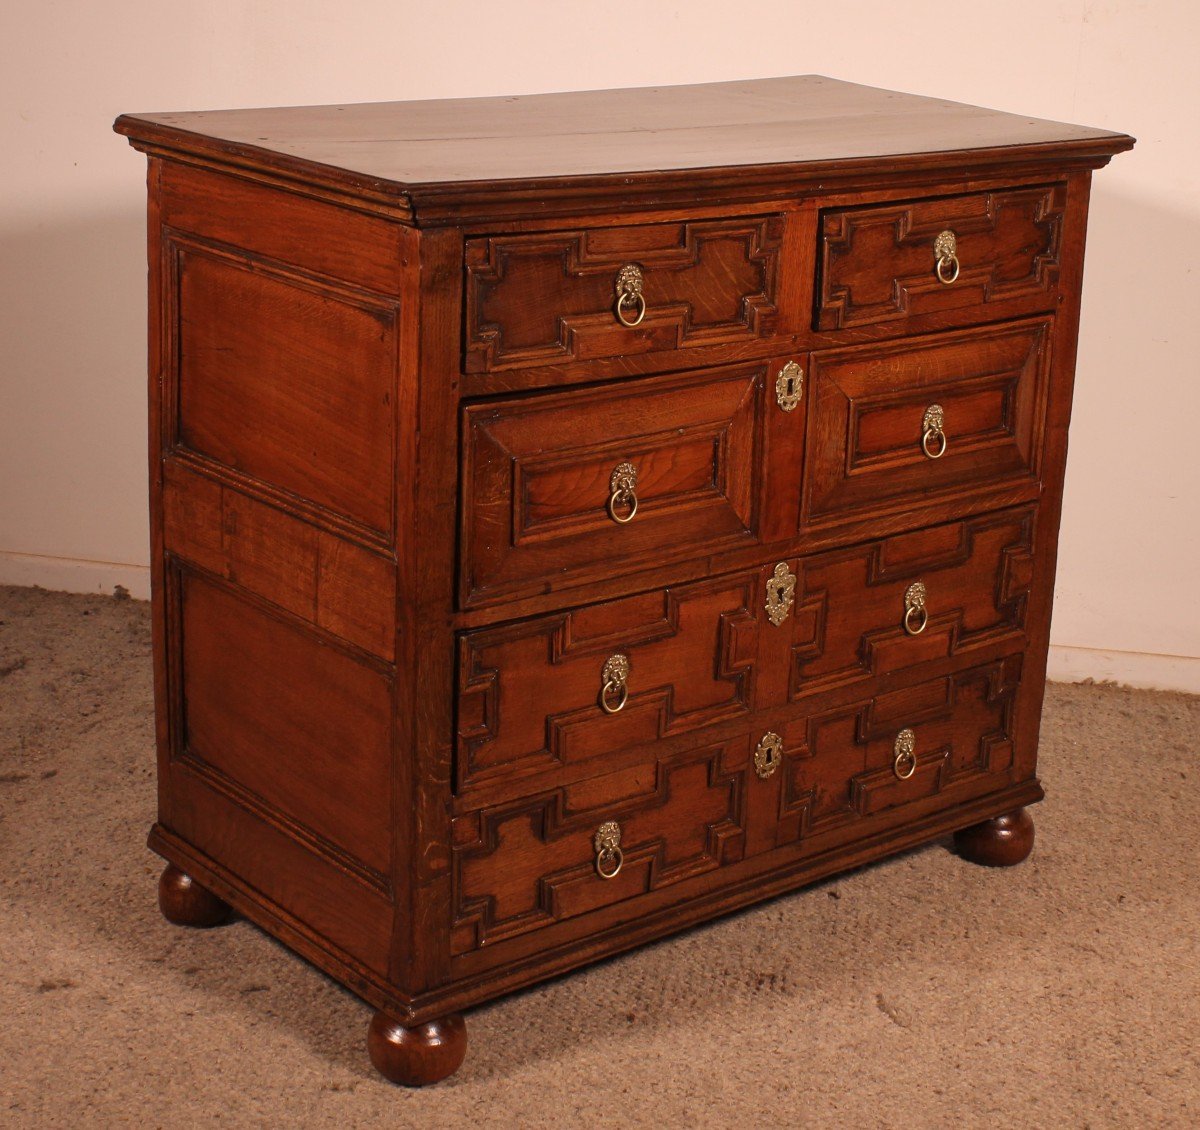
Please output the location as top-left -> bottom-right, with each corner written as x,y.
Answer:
0,588 -> 1200,1130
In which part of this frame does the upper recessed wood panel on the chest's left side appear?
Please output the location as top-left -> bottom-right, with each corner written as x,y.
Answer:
175,246 -> 397,534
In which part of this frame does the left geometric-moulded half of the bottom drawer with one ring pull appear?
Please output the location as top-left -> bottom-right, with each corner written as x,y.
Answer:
451,739 -> 749,955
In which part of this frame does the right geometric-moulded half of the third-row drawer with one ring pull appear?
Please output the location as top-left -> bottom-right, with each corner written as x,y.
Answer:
784,506 -> 1034,702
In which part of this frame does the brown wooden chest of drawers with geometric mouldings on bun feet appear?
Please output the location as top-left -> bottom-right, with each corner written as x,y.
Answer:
116,77 -> 1133,1083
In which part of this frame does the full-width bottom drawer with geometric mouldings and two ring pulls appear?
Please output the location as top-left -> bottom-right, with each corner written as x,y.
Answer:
451,656 -> 1021,957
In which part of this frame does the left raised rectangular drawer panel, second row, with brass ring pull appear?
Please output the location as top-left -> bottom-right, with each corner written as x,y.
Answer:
460,362 -> 777,606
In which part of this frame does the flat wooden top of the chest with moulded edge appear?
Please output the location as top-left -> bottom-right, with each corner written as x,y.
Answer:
115,74 -> 1133,220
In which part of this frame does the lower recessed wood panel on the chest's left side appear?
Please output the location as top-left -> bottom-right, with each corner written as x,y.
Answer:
176,572 -> 392,876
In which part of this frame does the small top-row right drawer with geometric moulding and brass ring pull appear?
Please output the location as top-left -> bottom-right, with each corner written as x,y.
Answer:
815,185 -> 1067,330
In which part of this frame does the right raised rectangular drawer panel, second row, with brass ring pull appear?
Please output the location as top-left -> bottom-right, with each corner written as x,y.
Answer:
802,320 -> 1050,527
